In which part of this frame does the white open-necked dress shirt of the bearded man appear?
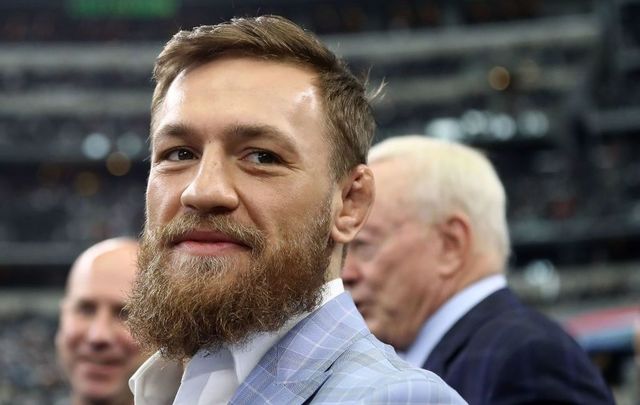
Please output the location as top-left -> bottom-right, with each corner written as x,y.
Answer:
129,278 -> 344,405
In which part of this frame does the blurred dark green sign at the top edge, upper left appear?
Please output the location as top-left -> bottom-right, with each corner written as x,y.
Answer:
67,0 -> 179,18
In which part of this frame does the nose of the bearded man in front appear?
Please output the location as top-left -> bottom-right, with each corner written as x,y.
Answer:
180,153 -> 239,213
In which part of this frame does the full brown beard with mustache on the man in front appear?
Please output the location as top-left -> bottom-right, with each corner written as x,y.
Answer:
126,201 -> 333,360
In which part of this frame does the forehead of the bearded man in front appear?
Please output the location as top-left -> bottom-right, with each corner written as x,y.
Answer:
154,57 -> 322,137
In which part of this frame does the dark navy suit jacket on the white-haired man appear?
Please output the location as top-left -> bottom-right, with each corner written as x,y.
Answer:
424,288 -> 614,405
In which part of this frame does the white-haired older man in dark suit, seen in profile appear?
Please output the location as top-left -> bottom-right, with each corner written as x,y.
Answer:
342,136 -> 613,405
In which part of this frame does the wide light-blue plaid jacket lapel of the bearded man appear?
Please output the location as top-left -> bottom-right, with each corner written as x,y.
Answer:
230,293 -> 369,404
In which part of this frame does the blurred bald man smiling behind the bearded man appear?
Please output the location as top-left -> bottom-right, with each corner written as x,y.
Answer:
56,238 -> 145,405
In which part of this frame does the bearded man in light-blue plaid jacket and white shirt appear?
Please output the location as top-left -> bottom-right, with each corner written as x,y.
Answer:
128,16 -> 463,404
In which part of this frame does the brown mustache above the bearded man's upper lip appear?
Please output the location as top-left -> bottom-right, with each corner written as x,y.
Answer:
143,212 -> 266,253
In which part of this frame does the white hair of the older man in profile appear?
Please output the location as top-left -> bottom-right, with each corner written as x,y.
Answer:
369,135 -> 510,265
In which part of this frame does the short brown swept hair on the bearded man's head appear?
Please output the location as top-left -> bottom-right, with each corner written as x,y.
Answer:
151,15 -> 375,179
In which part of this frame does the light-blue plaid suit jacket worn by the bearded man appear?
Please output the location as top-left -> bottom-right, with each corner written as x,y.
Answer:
230,293 -> 465,405
